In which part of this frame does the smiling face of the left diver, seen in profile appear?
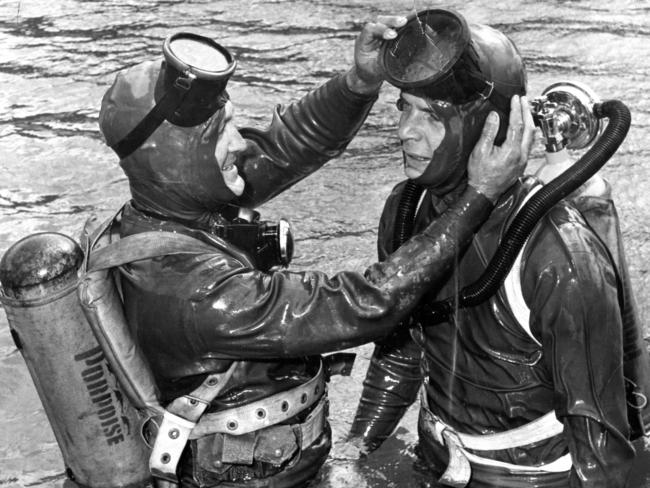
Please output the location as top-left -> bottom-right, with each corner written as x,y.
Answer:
214,101 -> 246,196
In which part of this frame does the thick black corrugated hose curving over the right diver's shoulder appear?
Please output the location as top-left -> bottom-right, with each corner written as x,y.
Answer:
423,100 -> 631,325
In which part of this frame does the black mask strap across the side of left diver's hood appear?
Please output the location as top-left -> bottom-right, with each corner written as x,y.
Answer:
111,74 -> 194,159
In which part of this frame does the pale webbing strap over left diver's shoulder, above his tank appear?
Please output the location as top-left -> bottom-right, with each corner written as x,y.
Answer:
88,231 -> 211,271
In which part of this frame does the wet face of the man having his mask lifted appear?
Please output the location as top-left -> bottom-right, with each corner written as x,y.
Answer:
397,93 -> 445,179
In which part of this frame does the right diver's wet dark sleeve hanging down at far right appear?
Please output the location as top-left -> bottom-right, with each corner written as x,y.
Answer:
523,212 -> 634,488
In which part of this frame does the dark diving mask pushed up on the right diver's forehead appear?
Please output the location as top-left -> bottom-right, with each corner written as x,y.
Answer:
380,9 -> 509,107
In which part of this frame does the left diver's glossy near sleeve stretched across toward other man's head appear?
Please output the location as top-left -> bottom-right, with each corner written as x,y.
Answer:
168,189 -> 491,359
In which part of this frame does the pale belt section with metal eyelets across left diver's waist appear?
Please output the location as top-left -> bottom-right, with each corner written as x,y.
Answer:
190,362 -> 325,439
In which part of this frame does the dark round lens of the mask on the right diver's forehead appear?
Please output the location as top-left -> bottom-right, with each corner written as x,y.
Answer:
381,10 -> 469,88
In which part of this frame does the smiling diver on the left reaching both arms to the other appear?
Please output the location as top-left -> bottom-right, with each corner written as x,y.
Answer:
100,18 -> 533,487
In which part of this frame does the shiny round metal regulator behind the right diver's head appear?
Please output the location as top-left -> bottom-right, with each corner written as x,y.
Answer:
531,81 -> 602,152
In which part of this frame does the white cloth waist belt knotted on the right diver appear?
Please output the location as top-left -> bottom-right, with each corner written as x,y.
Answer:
421,390 -> 571,487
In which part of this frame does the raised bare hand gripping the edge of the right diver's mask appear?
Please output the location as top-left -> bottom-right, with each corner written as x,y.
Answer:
346,15 -> 407,93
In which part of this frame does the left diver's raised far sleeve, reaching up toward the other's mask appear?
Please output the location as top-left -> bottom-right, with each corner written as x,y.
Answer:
233,75 -> 377,208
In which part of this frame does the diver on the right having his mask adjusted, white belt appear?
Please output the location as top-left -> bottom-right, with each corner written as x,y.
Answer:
350,7 -> 635,488
